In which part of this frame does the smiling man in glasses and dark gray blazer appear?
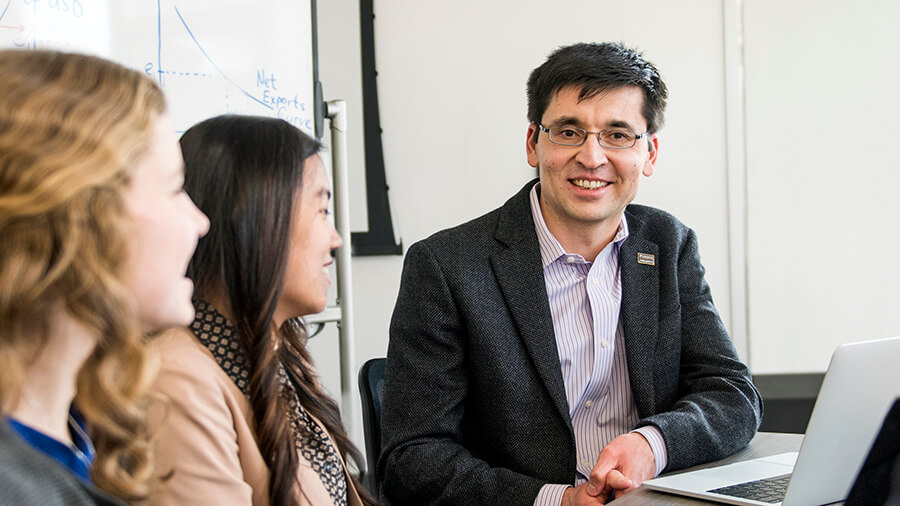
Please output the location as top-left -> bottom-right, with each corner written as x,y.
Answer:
378,44 -> 762,506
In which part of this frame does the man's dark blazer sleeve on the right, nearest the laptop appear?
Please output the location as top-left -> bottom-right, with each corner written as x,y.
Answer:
639,228 -> 762,471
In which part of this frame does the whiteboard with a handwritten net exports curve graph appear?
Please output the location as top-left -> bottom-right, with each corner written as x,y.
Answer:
0,0 -> 315,135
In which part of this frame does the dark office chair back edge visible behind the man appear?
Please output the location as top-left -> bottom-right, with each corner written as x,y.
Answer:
359,358 -> 385,497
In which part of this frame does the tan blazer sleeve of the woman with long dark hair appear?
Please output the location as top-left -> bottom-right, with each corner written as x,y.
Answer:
150,337 -> 259,506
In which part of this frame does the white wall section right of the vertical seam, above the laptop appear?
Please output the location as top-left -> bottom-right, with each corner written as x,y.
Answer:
744,0 -> 900,372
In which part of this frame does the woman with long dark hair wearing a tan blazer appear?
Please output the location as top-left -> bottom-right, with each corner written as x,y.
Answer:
152,116 -> 374,506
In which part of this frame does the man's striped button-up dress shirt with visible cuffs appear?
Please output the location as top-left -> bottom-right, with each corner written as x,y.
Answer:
530,183 -> 667,506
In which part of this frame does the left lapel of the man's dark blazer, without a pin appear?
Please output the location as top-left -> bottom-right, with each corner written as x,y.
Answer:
491,181 -> 572,430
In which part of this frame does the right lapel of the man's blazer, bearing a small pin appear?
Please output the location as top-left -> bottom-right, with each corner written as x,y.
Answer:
619,219 -> 659,417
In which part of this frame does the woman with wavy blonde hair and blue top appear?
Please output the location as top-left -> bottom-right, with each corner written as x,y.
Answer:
0,50 -> 208,504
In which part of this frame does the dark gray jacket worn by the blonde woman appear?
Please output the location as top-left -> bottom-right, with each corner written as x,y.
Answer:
0,422 -> 124,506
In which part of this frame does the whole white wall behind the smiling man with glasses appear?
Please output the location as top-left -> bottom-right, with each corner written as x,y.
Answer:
318,0 -> 900,458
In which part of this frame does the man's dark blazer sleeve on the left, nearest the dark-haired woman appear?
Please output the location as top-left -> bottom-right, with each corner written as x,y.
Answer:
378,243 -> 544,506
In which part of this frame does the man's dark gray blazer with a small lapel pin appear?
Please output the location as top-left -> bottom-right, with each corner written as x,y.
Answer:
378,181 -> 762,506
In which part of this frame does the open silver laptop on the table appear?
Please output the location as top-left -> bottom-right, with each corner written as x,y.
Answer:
643,337 -> 900,506
